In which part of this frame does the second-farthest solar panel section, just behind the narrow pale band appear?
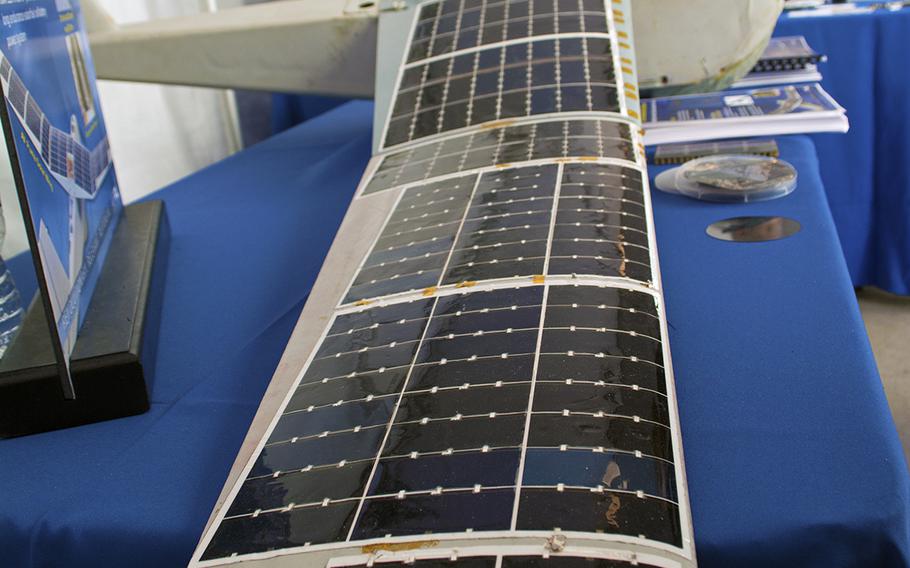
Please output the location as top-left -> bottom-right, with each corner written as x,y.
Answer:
383,35 -> 631,148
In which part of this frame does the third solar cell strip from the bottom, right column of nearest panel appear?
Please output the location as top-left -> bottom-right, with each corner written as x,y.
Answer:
528,414 -> 673,461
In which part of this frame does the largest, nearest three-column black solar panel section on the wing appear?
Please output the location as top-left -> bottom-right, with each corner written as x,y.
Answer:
204,286 -> 681,558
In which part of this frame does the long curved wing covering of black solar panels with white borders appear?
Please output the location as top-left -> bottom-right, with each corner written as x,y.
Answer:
194,0 -> 695,568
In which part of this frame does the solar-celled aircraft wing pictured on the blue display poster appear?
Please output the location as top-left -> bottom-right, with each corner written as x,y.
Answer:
0,55 -> 111,197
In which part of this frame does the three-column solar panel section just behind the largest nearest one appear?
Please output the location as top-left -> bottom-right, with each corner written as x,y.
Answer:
344,164 -> 650,303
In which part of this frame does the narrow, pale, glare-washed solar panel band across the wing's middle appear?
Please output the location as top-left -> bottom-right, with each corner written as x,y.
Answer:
358,120 -> 644,197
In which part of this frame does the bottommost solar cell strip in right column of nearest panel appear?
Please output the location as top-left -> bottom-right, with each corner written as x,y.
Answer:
517,489 -> 682,546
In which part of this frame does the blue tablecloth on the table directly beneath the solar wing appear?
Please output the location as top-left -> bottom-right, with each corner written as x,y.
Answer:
0,103 -> 910,568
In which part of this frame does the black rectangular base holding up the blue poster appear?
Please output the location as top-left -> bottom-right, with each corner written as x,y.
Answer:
0,201 -> 168,438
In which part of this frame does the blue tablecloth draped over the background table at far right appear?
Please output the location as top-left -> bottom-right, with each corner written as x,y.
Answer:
775,9 -> 910,294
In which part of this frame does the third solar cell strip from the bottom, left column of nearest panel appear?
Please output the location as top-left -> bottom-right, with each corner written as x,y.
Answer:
249,428 -> 385,477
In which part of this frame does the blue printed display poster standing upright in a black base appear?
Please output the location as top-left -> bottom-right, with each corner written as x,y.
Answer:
0,0 -> 122,396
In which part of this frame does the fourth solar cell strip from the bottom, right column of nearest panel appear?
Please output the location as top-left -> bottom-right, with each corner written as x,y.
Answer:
533,381 -> 670,427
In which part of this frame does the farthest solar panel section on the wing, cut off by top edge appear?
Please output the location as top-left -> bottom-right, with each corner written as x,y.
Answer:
407,0 -> 608,64
